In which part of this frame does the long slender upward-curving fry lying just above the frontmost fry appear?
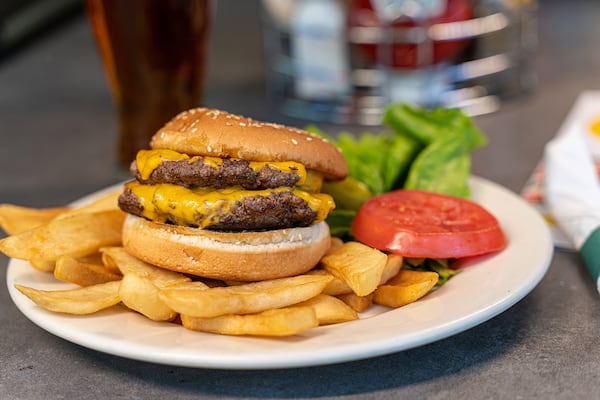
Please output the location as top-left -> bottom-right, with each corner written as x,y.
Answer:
160,275 -> 331,318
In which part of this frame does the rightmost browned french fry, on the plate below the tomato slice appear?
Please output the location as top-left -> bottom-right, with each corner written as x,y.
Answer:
373,269 -> 438,307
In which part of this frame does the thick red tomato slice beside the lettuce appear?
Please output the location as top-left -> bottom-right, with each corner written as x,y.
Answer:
351,190 -> 507,258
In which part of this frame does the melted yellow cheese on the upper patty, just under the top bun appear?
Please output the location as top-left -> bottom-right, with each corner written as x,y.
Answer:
135,149 -> 307,185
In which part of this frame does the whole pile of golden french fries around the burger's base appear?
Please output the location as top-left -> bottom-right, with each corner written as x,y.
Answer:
0,192 -> 438,336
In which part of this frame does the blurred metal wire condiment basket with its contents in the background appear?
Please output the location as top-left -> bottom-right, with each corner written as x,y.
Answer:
263,0 -> 537,125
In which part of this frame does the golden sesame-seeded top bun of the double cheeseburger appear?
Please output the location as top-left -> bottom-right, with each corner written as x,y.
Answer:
150,108 -> 348,180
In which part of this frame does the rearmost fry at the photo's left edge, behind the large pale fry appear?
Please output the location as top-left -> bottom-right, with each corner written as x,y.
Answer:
0,204 -> 69,235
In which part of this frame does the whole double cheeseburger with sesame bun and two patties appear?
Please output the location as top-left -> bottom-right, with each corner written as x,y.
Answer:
119,108 -> 348,281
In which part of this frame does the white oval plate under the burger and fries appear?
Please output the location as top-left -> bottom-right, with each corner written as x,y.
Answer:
7,178 -> 552,369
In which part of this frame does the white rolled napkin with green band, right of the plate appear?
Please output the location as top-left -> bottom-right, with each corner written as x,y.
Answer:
544,94 -> 600,292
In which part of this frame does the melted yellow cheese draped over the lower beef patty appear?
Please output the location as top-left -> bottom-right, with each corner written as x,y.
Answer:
126,182 -> 335,228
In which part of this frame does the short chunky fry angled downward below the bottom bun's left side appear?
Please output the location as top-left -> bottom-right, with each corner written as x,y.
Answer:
119,273 -> 177,321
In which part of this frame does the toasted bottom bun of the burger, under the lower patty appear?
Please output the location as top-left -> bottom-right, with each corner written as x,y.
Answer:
123,215 -> 331,281
